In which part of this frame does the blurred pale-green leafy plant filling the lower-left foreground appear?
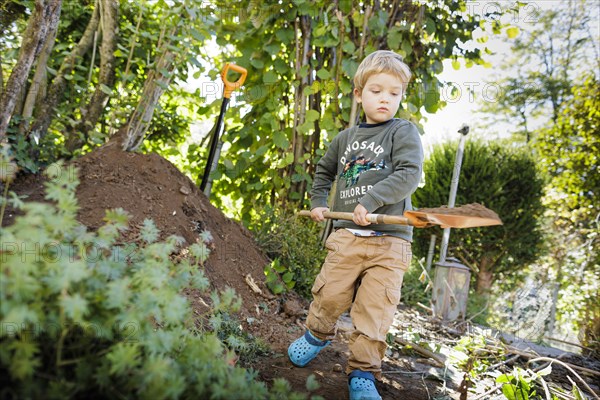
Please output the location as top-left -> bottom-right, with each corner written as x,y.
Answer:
0,165 -> 304,399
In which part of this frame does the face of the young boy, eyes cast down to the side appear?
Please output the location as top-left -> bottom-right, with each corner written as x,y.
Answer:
354,72 -> 403,124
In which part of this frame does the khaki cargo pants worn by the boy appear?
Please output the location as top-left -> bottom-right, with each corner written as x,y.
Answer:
306,229 -> 412,379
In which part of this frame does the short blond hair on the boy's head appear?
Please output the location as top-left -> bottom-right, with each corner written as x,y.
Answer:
354,50 -> 412,92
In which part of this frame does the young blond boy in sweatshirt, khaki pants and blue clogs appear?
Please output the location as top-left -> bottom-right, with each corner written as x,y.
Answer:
288,51 -> 423,400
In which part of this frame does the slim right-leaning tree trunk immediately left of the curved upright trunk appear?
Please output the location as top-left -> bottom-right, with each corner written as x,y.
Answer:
30,0 -> 100,143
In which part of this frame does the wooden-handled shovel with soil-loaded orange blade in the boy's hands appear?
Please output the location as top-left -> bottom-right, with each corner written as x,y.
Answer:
298,204 -> 502,228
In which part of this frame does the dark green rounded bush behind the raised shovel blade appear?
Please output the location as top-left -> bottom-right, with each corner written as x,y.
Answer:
413,139 -> 544,293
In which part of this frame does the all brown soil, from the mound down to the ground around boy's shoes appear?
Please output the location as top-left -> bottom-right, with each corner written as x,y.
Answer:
5,145 -> 457,400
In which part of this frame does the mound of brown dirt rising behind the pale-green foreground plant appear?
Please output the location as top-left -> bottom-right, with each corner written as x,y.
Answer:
4,144 -> 298,342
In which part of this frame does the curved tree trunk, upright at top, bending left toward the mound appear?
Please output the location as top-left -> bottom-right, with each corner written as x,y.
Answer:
67,0 -> 119,152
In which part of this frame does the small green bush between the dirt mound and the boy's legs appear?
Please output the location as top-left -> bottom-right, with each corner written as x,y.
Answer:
250,207 -> 327,298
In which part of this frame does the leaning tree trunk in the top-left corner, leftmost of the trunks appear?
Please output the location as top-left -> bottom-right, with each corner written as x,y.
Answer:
0,0 -> 61,143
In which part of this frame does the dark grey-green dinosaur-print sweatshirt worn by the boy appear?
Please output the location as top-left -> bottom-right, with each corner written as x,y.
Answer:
310,119 -> 423,241
